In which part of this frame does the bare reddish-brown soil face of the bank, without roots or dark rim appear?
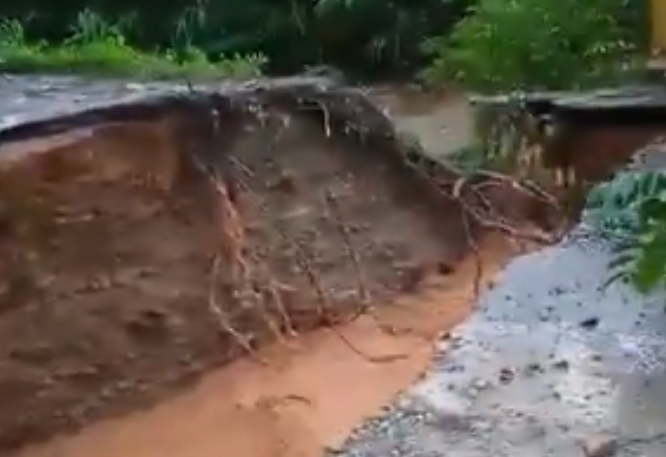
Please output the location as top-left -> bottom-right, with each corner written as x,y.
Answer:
0,113 -> 466,449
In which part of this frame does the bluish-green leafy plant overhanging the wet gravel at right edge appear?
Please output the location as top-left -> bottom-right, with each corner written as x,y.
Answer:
585,171 -> 666,293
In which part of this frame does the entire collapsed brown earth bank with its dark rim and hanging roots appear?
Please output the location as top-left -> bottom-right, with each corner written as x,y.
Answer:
0,76 -> 550,449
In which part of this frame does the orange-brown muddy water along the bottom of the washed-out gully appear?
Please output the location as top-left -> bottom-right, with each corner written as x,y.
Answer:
12,235 -> 511,457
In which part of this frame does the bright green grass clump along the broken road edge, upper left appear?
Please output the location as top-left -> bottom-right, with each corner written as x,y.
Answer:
0,10 -> 266,79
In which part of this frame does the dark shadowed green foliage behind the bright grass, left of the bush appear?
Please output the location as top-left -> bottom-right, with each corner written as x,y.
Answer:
0,0 -> 466,76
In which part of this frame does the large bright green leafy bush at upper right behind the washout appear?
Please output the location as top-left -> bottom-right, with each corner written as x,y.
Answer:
423,0 -> 646,92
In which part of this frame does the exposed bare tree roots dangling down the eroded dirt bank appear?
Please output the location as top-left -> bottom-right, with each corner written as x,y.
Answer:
189,78 -> 560,363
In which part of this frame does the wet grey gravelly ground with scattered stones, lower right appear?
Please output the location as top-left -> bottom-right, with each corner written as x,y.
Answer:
331,223 -> 666,457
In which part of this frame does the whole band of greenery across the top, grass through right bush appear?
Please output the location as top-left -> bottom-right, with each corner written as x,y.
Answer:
0,0 -> 646,83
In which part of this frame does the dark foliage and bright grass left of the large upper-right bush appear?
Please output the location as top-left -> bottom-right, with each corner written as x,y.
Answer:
0,0 -> 474,77
